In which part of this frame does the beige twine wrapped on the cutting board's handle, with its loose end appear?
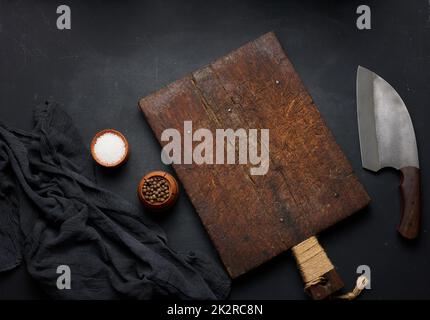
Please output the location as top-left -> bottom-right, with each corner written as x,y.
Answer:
292,237 -> 368,300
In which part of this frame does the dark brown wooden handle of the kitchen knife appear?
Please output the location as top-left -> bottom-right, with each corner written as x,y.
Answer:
397,167 -> 421,239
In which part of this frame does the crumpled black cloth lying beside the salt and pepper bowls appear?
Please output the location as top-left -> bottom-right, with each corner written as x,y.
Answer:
0,102 -> 230,299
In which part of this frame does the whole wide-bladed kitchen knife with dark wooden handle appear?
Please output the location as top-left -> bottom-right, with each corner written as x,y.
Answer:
357,66 -> 421,239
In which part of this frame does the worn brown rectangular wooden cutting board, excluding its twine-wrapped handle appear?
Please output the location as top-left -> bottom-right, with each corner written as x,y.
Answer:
139,33 -> 369,278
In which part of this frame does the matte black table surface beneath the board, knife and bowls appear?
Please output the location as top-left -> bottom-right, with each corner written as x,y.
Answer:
0,0 -> 430,299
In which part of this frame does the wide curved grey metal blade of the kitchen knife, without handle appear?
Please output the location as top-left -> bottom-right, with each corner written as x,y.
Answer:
357,66 -> 419,171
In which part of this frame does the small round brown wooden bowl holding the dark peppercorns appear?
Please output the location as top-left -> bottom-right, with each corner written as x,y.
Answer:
137,171 -> 179,211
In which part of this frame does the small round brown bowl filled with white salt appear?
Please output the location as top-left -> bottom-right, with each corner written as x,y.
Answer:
91,129 -> 129,168
